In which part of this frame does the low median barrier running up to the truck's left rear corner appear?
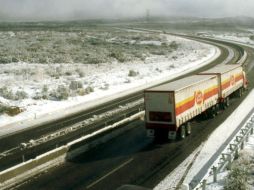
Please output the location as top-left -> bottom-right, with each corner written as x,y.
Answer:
0,111 -> 145,190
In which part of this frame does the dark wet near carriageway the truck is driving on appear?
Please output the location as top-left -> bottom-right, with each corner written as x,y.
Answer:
10,33 -> 254,189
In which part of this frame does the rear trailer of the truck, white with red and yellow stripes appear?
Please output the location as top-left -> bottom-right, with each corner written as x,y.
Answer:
144,75 -> 220,139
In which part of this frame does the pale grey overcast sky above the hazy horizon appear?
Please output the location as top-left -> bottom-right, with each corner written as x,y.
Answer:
0,0 -> 254,20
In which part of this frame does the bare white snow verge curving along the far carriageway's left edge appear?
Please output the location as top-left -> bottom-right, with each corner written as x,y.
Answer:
0,36 -> 220,136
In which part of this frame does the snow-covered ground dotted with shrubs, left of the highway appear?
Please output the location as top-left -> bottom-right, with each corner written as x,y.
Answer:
0,35 -> 218,135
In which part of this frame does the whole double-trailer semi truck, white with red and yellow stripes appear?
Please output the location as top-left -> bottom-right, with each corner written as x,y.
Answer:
144,65 -> 247,139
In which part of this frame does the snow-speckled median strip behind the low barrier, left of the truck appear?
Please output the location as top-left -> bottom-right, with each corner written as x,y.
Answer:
0,99 -> 144,170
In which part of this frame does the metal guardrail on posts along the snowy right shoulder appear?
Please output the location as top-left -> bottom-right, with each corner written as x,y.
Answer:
192,112 -> 254,190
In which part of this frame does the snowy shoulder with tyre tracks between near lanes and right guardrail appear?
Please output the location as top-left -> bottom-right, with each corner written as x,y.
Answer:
154,91 -> 254,190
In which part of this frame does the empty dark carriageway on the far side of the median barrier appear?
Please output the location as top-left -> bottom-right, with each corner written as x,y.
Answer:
0,32 -> 242,171
